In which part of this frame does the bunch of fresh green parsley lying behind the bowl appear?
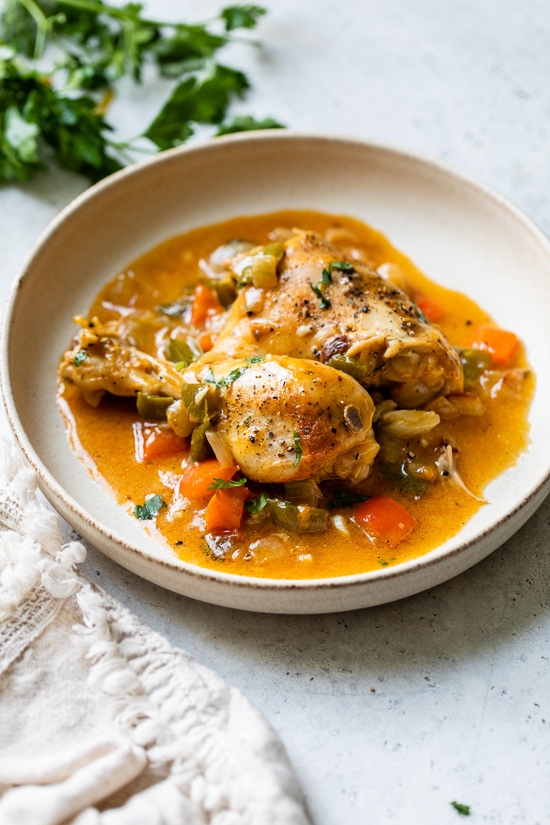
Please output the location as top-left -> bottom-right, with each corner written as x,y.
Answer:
0,0 -> 280,181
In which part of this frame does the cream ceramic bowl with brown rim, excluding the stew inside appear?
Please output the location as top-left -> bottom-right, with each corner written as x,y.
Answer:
1,131 -> 550,613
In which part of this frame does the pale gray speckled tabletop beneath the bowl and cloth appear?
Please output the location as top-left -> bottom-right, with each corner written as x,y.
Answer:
0,0 -> 550,825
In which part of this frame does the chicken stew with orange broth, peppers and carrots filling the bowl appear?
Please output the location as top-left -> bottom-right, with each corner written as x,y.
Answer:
59,211 -> 534,579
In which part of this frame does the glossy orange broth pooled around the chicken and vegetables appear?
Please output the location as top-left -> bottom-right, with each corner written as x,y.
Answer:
59,211 -> 535,579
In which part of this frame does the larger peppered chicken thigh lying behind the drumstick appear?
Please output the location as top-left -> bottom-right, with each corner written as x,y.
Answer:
205,230 -> 463,408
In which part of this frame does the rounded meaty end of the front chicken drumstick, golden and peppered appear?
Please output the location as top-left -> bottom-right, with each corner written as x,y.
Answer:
195,355 -> 379,483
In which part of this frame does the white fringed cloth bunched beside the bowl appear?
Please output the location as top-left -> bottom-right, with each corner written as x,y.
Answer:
0,440 -> 309,825
